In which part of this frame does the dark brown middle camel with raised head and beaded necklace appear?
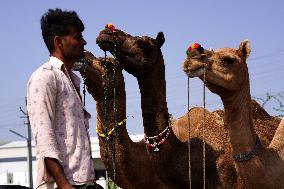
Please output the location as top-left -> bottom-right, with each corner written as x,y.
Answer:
97,28 -> 219,189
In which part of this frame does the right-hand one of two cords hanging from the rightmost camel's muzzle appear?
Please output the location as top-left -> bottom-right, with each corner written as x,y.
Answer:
202,65 -> 206,189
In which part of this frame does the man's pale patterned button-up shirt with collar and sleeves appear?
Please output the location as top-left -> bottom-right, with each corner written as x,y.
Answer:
27,57 -> 95,186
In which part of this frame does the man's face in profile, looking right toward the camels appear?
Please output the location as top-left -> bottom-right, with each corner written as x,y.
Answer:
61,28 -> 87,61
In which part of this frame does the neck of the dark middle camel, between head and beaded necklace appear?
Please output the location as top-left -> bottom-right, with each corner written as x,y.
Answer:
137,56 -> 168,136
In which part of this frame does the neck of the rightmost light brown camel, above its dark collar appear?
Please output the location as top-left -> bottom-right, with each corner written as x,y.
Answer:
222,88 -> 256,154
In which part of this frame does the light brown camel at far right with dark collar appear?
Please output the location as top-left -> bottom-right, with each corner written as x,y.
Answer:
183,41 -> 284,188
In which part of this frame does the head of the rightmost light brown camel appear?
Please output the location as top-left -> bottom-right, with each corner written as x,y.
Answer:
183,40 -> 251,97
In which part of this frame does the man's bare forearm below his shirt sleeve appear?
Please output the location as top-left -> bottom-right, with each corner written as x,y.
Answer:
44,157 -> 74,189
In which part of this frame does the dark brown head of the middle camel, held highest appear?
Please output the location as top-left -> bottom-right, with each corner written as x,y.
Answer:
97,25 -> 165,77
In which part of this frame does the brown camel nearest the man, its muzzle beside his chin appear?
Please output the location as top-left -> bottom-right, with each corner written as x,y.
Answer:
77,52 -> 170,189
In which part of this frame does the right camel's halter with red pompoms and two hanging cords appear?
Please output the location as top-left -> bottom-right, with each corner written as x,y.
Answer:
186,43 -> 206,189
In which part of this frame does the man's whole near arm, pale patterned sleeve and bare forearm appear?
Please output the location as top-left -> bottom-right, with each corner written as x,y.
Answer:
27,69 -> 73,189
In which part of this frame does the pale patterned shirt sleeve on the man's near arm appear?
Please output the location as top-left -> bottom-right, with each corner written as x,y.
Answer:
27,68 -> 62,179
